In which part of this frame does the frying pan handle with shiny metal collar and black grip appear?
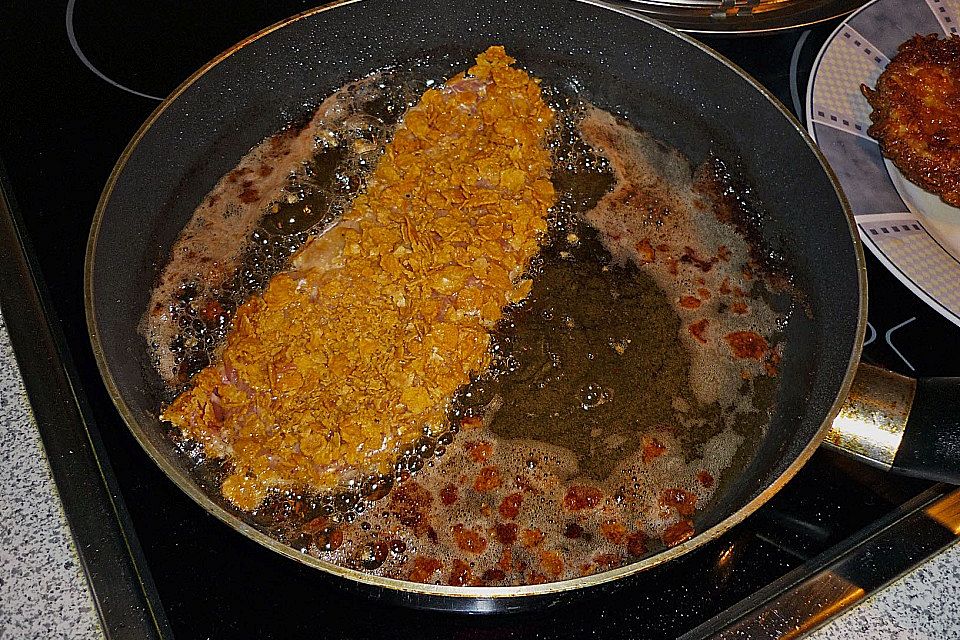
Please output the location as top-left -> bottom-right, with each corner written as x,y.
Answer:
824,363 -> 960,484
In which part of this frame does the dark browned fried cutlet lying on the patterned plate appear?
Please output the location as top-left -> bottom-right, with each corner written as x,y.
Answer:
860,34 -> 960,206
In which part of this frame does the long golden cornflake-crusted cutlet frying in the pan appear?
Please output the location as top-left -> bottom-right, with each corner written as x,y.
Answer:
161,46 -> 555,510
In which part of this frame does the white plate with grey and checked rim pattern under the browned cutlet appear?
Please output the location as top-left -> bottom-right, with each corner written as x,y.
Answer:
806,0 -> 960,325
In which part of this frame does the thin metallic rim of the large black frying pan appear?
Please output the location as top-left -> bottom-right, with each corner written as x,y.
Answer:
83,0 -> 867,600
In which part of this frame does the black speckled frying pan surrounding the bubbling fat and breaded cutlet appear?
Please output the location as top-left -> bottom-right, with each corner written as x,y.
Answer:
86,0 -> 960,611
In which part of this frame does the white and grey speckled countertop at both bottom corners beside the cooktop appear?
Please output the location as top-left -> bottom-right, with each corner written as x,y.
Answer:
0,300 -> 960,640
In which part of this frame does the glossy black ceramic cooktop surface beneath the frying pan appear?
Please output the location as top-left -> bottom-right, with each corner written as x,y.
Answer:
0,0 -> 960,639
